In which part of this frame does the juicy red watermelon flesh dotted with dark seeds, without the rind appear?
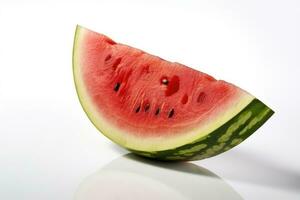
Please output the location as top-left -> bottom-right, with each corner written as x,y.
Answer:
78,27 -> 245,136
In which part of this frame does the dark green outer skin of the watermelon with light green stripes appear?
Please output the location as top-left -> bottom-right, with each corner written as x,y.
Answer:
129,99 -> 274,160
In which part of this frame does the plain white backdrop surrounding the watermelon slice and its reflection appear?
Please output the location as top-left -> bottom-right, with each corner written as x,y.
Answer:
0,0 -> 300,200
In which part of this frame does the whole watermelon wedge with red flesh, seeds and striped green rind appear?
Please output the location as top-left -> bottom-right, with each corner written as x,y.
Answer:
73,26 -> 274,160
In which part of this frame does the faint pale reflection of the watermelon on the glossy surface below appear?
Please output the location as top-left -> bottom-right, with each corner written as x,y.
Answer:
75,154 -> 242,200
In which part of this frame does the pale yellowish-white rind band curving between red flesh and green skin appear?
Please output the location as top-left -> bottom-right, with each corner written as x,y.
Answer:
73,25 -> 274,153
